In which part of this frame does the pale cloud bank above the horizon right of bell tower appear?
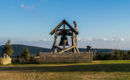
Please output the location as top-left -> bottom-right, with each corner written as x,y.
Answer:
79,37 -> 127,49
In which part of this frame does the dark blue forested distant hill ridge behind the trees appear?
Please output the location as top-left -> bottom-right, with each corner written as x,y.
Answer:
0,44 -> 112,56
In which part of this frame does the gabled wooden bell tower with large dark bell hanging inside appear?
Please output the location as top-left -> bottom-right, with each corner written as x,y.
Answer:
50,20 -> 80,54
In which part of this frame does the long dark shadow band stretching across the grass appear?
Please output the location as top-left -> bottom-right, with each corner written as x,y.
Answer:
0,64 -> 130,72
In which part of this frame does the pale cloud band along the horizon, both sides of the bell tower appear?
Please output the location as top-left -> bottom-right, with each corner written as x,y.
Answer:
0,37 -> 130,49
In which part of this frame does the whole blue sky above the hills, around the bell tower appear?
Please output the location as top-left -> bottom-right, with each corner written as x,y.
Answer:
0,0 -> 130,49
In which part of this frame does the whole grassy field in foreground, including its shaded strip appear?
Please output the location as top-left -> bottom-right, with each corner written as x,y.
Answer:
0,60 -> 130,80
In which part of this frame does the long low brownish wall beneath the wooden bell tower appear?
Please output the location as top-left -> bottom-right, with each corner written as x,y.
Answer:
39,52 -> 93,63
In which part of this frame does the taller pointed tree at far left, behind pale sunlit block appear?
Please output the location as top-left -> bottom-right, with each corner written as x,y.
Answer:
2,40 -> 14,57
